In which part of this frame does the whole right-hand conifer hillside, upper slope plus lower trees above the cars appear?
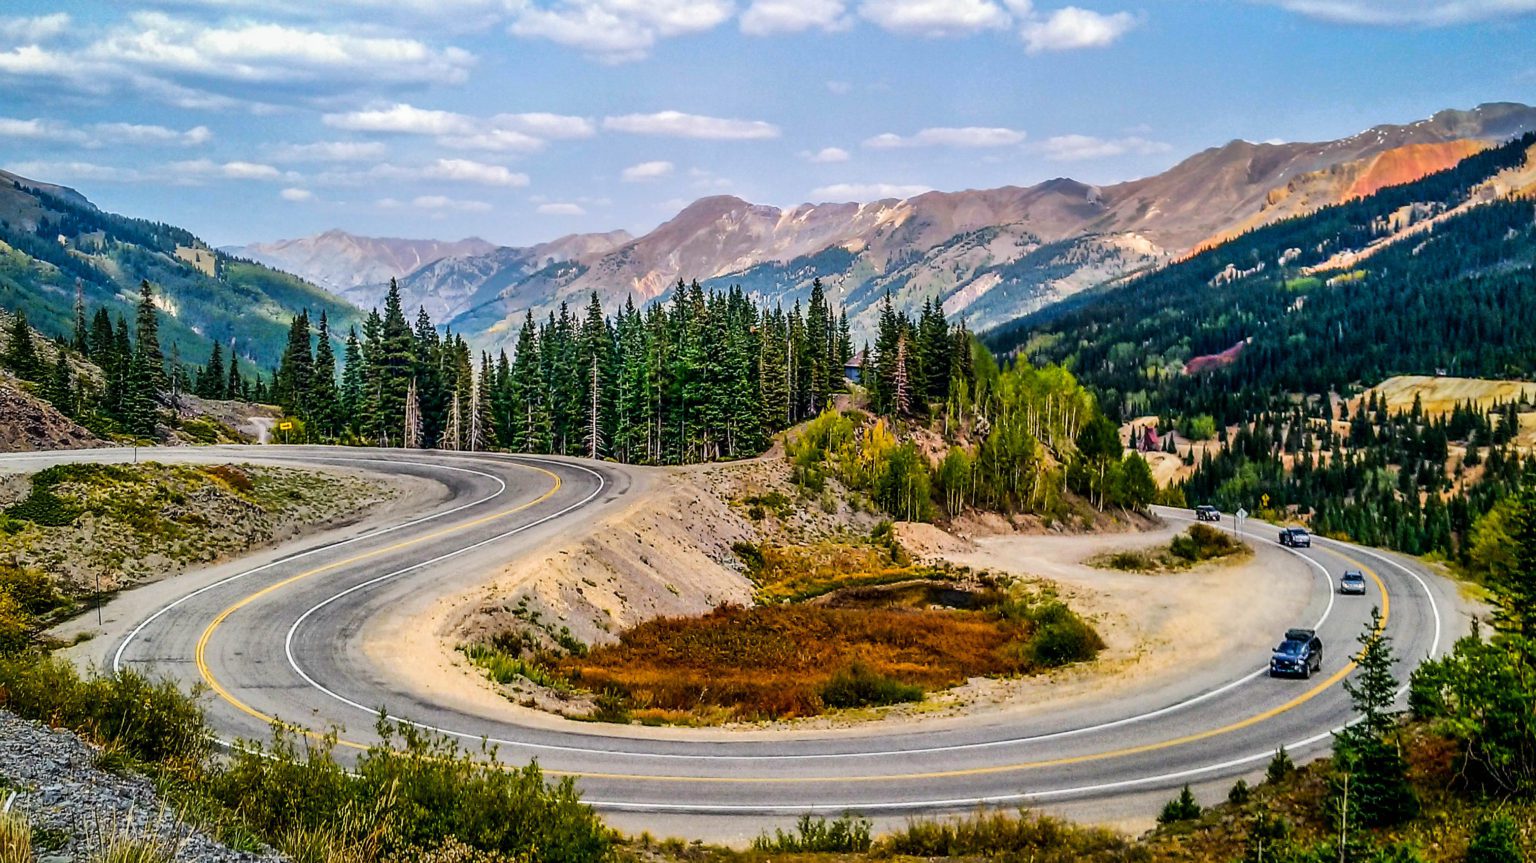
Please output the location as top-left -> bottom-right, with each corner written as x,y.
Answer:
988,128 -> 1536,562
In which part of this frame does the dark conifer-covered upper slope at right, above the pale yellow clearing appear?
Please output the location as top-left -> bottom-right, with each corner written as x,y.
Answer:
986,135 -> 1536,421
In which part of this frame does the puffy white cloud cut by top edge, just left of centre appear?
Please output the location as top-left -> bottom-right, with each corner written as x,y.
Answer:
510,0 -> 736,63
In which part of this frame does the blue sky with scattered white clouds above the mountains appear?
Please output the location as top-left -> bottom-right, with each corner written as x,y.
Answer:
0,0 -> 1536,246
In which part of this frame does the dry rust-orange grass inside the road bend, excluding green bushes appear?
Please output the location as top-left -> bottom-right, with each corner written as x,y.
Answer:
559,605 -> 1032,720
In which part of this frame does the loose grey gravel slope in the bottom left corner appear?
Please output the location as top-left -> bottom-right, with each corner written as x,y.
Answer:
0,711 -> 278,863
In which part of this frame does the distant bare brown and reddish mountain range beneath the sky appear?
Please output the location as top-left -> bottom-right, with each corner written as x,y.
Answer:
227,103 -> 1536,347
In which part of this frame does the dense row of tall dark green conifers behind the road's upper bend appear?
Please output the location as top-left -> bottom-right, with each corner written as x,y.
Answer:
258,281 -> 872,464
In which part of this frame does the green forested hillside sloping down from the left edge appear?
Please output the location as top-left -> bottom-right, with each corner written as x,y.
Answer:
0,172 -> 358,367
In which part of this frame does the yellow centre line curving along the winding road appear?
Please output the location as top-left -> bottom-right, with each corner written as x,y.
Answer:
197,500 -> 1392,785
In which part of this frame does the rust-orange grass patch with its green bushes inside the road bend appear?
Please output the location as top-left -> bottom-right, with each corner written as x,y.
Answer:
556,585 -> 1103,725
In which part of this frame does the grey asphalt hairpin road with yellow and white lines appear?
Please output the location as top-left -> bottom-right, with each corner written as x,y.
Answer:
0,447 -> 1465,840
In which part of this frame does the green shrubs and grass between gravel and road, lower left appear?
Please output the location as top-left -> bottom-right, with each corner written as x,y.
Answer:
0,653 -> 616,863
